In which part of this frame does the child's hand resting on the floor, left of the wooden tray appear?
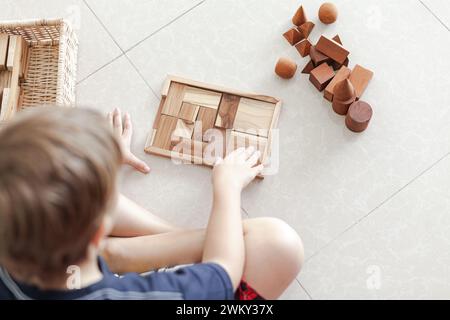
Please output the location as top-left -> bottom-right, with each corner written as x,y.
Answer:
108,108 -> 150,173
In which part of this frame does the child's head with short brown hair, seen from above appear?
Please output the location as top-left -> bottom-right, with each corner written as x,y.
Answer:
0,107 -> 122,280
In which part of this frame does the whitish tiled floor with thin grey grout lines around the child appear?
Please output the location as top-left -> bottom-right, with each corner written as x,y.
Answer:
0,0 -> 450,299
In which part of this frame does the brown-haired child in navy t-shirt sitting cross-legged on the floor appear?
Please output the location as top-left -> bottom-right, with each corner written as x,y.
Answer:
0,107 -> 303,299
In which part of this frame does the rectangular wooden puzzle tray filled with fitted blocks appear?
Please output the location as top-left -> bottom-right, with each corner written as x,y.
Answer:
145,76 -> 282,176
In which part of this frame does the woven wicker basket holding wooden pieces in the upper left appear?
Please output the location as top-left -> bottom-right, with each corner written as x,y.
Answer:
0,19 -> 78,110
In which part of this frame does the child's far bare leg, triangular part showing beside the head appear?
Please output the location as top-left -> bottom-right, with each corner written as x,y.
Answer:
111,195 -> 180,237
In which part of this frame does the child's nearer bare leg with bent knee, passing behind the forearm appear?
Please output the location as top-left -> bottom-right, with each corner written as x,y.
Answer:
103,218 -> 303,299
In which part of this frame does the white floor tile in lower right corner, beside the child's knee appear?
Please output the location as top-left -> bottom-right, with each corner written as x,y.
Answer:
299,157 -> 450,299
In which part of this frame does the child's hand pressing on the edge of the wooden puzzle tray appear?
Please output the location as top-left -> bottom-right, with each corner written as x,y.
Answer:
213,147 -> 264,192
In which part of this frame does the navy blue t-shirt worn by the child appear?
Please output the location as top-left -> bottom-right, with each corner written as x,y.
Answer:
0,258 -> 234,300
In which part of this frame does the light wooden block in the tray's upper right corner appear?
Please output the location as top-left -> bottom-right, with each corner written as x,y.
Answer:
233,98 -> 275,137
